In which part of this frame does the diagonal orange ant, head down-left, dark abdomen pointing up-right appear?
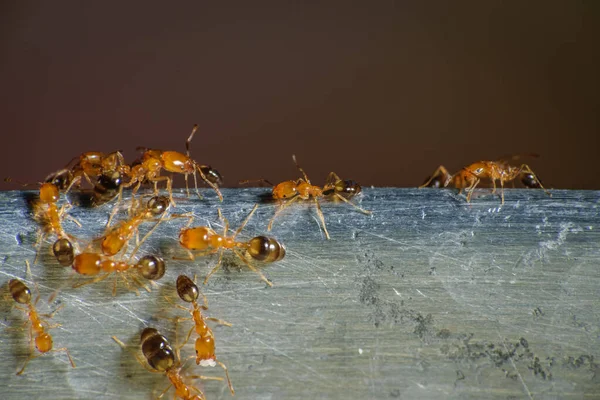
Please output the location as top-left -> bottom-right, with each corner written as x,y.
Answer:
99,196 -> 169,256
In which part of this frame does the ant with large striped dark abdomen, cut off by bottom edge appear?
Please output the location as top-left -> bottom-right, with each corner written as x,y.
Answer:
112,328 -> 222,400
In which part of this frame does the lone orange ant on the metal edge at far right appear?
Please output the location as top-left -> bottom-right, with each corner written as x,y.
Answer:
419,160 -> 552,204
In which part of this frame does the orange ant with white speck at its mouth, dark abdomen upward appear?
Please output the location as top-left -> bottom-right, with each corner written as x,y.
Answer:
167,275 -> 235,395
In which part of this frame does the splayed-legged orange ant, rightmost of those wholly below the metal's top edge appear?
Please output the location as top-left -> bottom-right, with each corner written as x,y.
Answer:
179,204 -> 285,286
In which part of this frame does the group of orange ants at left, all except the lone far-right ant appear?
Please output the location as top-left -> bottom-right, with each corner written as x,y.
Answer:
8,125 -> 378,399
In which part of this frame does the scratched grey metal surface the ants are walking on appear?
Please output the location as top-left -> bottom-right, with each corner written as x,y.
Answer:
0,189 -> 600,399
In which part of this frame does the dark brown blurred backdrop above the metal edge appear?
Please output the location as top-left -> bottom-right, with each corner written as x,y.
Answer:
0,0 -> 600,189
